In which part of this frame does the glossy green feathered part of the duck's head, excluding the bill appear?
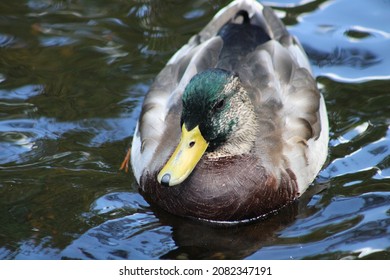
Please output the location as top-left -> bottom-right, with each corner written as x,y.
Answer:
181,69 -> 240,150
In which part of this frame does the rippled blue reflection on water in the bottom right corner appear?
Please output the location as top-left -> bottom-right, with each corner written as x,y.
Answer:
249,192 -> 390,259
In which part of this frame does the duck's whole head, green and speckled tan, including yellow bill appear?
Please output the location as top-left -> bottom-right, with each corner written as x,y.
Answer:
157,69 -> 255,186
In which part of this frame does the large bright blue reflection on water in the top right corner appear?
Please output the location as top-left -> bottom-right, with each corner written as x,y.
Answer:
290,0 -> 390,82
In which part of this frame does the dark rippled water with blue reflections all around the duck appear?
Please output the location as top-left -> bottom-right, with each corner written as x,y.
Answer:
0,0 -> 390,259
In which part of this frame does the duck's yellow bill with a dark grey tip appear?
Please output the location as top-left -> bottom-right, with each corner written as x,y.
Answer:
157,124 -> 209,186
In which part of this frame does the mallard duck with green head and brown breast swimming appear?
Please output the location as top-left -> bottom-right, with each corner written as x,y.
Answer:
122,0 -> 328,222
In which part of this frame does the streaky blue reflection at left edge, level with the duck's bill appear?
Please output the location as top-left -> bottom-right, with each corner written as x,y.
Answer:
0,117 -> 134,164
